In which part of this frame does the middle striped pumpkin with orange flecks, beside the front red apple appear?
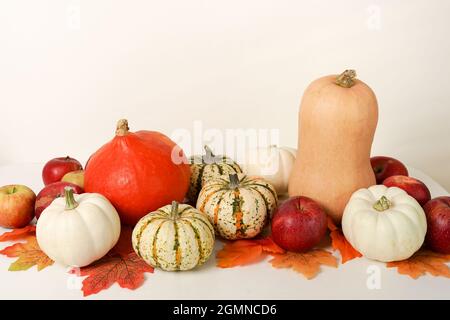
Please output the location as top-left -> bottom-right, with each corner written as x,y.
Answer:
197,174 -> 278,240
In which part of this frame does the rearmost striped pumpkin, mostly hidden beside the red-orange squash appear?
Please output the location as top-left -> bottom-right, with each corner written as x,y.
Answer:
187,146 -> 242,205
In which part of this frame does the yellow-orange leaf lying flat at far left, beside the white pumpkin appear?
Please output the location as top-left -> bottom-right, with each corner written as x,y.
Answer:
0,236 -> 53,271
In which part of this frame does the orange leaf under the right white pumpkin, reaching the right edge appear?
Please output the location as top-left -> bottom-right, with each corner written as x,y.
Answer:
386,250 -> 450,279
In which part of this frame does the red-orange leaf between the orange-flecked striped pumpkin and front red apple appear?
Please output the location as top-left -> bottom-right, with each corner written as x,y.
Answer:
216,237 -> 284,268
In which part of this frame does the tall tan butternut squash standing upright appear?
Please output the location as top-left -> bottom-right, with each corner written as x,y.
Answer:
289,70 -> 378,223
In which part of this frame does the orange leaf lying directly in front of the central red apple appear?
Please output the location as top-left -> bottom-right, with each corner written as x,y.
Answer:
269,249 -> 338,280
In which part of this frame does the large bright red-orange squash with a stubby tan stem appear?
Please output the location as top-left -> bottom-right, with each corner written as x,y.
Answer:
85,120 -> 190,225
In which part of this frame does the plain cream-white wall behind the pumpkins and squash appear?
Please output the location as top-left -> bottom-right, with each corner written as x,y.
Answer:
0,0 -> 450,189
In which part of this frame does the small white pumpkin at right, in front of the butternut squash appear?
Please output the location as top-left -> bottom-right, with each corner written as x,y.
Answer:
342,185 -> 427,262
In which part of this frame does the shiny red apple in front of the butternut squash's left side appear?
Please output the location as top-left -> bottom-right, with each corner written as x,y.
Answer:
272,196 -> 327,252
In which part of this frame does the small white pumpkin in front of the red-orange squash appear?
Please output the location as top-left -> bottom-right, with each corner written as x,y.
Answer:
36,187 -> 120,267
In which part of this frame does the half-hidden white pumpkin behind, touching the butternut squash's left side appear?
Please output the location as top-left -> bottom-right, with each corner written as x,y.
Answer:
241,145 -> 297,196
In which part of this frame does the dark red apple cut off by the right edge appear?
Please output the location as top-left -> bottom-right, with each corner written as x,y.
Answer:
424,197 -> 450,254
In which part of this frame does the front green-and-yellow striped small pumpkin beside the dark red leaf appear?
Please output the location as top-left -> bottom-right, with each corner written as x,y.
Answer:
132,201 -> 214,271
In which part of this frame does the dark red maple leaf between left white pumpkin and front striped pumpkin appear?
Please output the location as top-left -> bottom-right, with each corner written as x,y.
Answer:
69,226 -> 154,297
